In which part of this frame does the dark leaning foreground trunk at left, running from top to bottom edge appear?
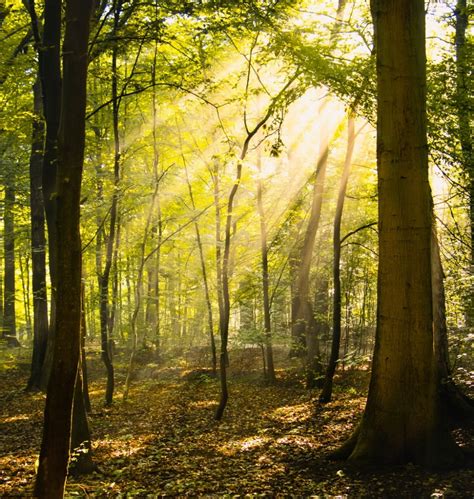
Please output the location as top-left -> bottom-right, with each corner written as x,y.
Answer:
34,0 -> 92,499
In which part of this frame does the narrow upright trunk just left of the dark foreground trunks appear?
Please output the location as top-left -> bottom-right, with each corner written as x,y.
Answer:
27,80 -> 48,390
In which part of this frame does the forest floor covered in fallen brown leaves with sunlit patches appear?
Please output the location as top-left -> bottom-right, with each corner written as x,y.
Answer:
0,350 -> 474,498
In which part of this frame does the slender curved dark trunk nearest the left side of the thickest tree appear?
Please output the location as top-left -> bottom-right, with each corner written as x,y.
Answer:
319,114 -> 355,402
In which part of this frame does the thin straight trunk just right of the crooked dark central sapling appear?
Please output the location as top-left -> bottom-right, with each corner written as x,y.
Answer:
257,156 -> 276,383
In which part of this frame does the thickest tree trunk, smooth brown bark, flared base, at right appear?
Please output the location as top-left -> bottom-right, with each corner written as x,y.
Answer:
339,0 -> 458,465
